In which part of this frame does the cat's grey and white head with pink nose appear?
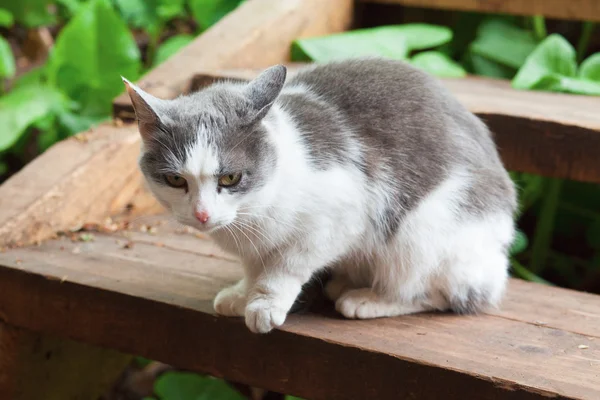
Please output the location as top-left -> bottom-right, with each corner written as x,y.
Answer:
123,65 -> 286,231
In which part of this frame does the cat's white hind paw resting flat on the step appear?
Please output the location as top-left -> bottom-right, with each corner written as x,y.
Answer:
335,289 -> 399,319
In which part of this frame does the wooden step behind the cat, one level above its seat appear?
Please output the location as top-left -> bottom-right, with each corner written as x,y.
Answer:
190,70 -> 600,183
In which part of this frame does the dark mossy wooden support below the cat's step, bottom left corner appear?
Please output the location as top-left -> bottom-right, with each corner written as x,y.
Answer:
0,320 -> 132,400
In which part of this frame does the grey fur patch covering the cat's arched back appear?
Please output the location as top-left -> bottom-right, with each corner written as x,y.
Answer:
281,58 -> 514,217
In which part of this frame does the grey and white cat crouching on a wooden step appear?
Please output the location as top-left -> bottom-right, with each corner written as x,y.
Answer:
125,58 -> 516,332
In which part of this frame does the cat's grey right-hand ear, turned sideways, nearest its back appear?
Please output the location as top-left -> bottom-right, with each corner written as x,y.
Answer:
245,65 -> 287,120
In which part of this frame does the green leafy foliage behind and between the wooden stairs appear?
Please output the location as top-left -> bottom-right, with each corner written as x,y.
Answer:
0,0 -> 600,400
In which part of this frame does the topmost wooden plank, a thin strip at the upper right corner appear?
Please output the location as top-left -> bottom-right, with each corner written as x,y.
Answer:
359,0 -> 600,21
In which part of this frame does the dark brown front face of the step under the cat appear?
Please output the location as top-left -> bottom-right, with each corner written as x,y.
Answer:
0,268 -> 555,400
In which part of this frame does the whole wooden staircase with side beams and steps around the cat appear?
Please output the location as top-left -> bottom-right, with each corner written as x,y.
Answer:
0,0 -> 600,400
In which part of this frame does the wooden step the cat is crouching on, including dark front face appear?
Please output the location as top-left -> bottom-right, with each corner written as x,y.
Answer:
0,217 -> 600,400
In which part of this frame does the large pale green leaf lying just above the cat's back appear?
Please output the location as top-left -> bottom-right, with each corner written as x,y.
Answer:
292,24 -> 452,62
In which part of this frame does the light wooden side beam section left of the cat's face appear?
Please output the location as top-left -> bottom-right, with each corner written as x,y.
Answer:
0,124 -> 162,247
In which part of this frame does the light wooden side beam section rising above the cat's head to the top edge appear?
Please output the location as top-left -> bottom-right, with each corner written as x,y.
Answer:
113,0 -> 353,121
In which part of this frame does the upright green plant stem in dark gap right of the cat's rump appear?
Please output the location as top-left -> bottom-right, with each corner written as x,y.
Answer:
530,179 -> 563,274
